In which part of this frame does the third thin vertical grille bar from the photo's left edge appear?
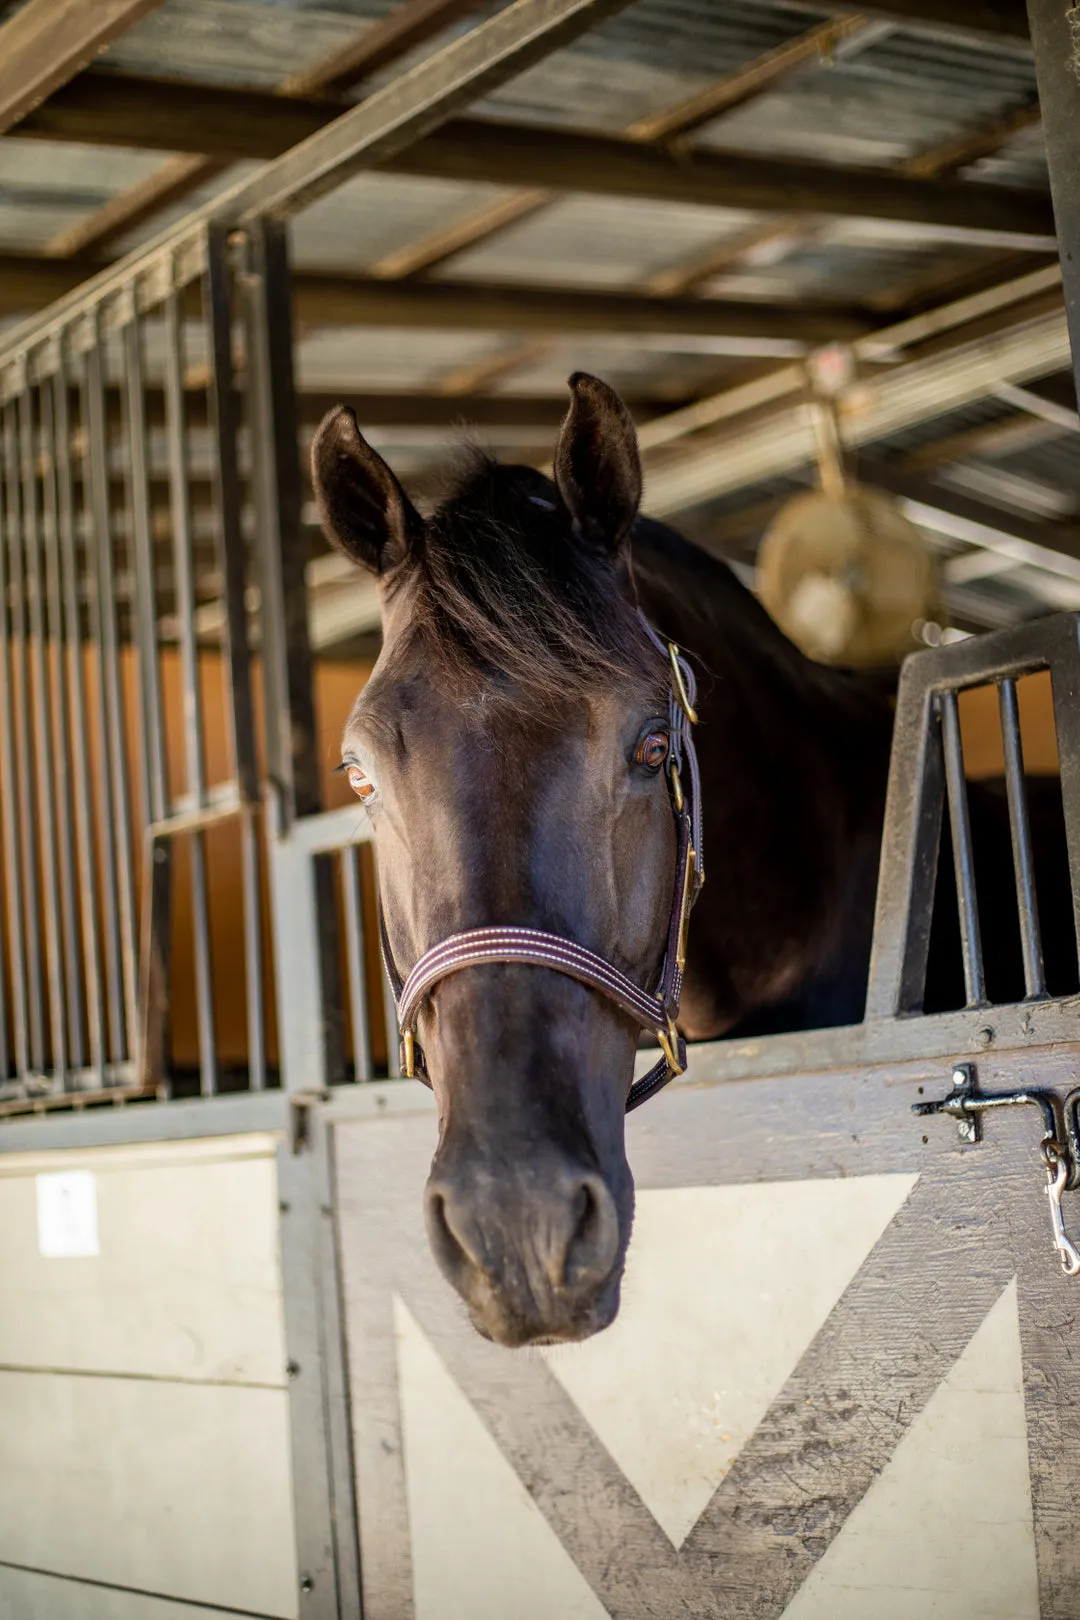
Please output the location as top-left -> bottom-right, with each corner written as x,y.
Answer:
40,382 -> 86,1069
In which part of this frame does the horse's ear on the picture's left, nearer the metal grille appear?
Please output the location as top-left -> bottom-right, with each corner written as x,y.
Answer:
311,405 -> 423,573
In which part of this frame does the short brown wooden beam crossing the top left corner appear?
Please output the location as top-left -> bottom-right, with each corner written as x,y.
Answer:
0,0 -> 162,134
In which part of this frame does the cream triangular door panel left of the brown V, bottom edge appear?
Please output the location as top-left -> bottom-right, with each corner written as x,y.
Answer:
393,1294 -> 607,1620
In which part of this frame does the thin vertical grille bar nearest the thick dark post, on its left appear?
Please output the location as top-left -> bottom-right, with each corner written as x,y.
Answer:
164,292 -> 217,1097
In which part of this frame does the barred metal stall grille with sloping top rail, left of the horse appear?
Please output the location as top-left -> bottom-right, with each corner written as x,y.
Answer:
0,0 -> 628,1111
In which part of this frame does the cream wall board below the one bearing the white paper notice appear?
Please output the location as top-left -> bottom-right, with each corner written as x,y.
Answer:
0,1372 -> 298,1620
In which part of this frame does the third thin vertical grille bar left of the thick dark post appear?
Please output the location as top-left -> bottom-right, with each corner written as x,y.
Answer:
84,341 -> 139,1059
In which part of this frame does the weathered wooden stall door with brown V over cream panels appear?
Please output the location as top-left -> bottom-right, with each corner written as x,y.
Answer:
334,1047 -> 1080,1620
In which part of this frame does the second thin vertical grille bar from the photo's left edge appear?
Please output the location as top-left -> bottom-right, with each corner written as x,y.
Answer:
18,389 -> 68,1084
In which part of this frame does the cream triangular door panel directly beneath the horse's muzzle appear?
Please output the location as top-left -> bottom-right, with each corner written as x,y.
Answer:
542,1175 -> 918,1547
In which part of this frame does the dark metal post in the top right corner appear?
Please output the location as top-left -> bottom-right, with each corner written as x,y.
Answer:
1028,0 -> 1080,411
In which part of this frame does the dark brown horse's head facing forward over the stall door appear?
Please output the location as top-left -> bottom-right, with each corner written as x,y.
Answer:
313,374 -> 678,1346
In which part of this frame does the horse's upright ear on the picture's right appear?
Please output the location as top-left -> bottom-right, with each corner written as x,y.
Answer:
554,371 -> 641,551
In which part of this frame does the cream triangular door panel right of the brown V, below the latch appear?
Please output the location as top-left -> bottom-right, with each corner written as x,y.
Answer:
784,1281 -> 1040,1620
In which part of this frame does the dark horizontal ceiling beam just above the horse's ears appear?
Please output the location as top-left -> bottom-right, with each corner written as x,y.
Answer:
0,254 -> 871,343
